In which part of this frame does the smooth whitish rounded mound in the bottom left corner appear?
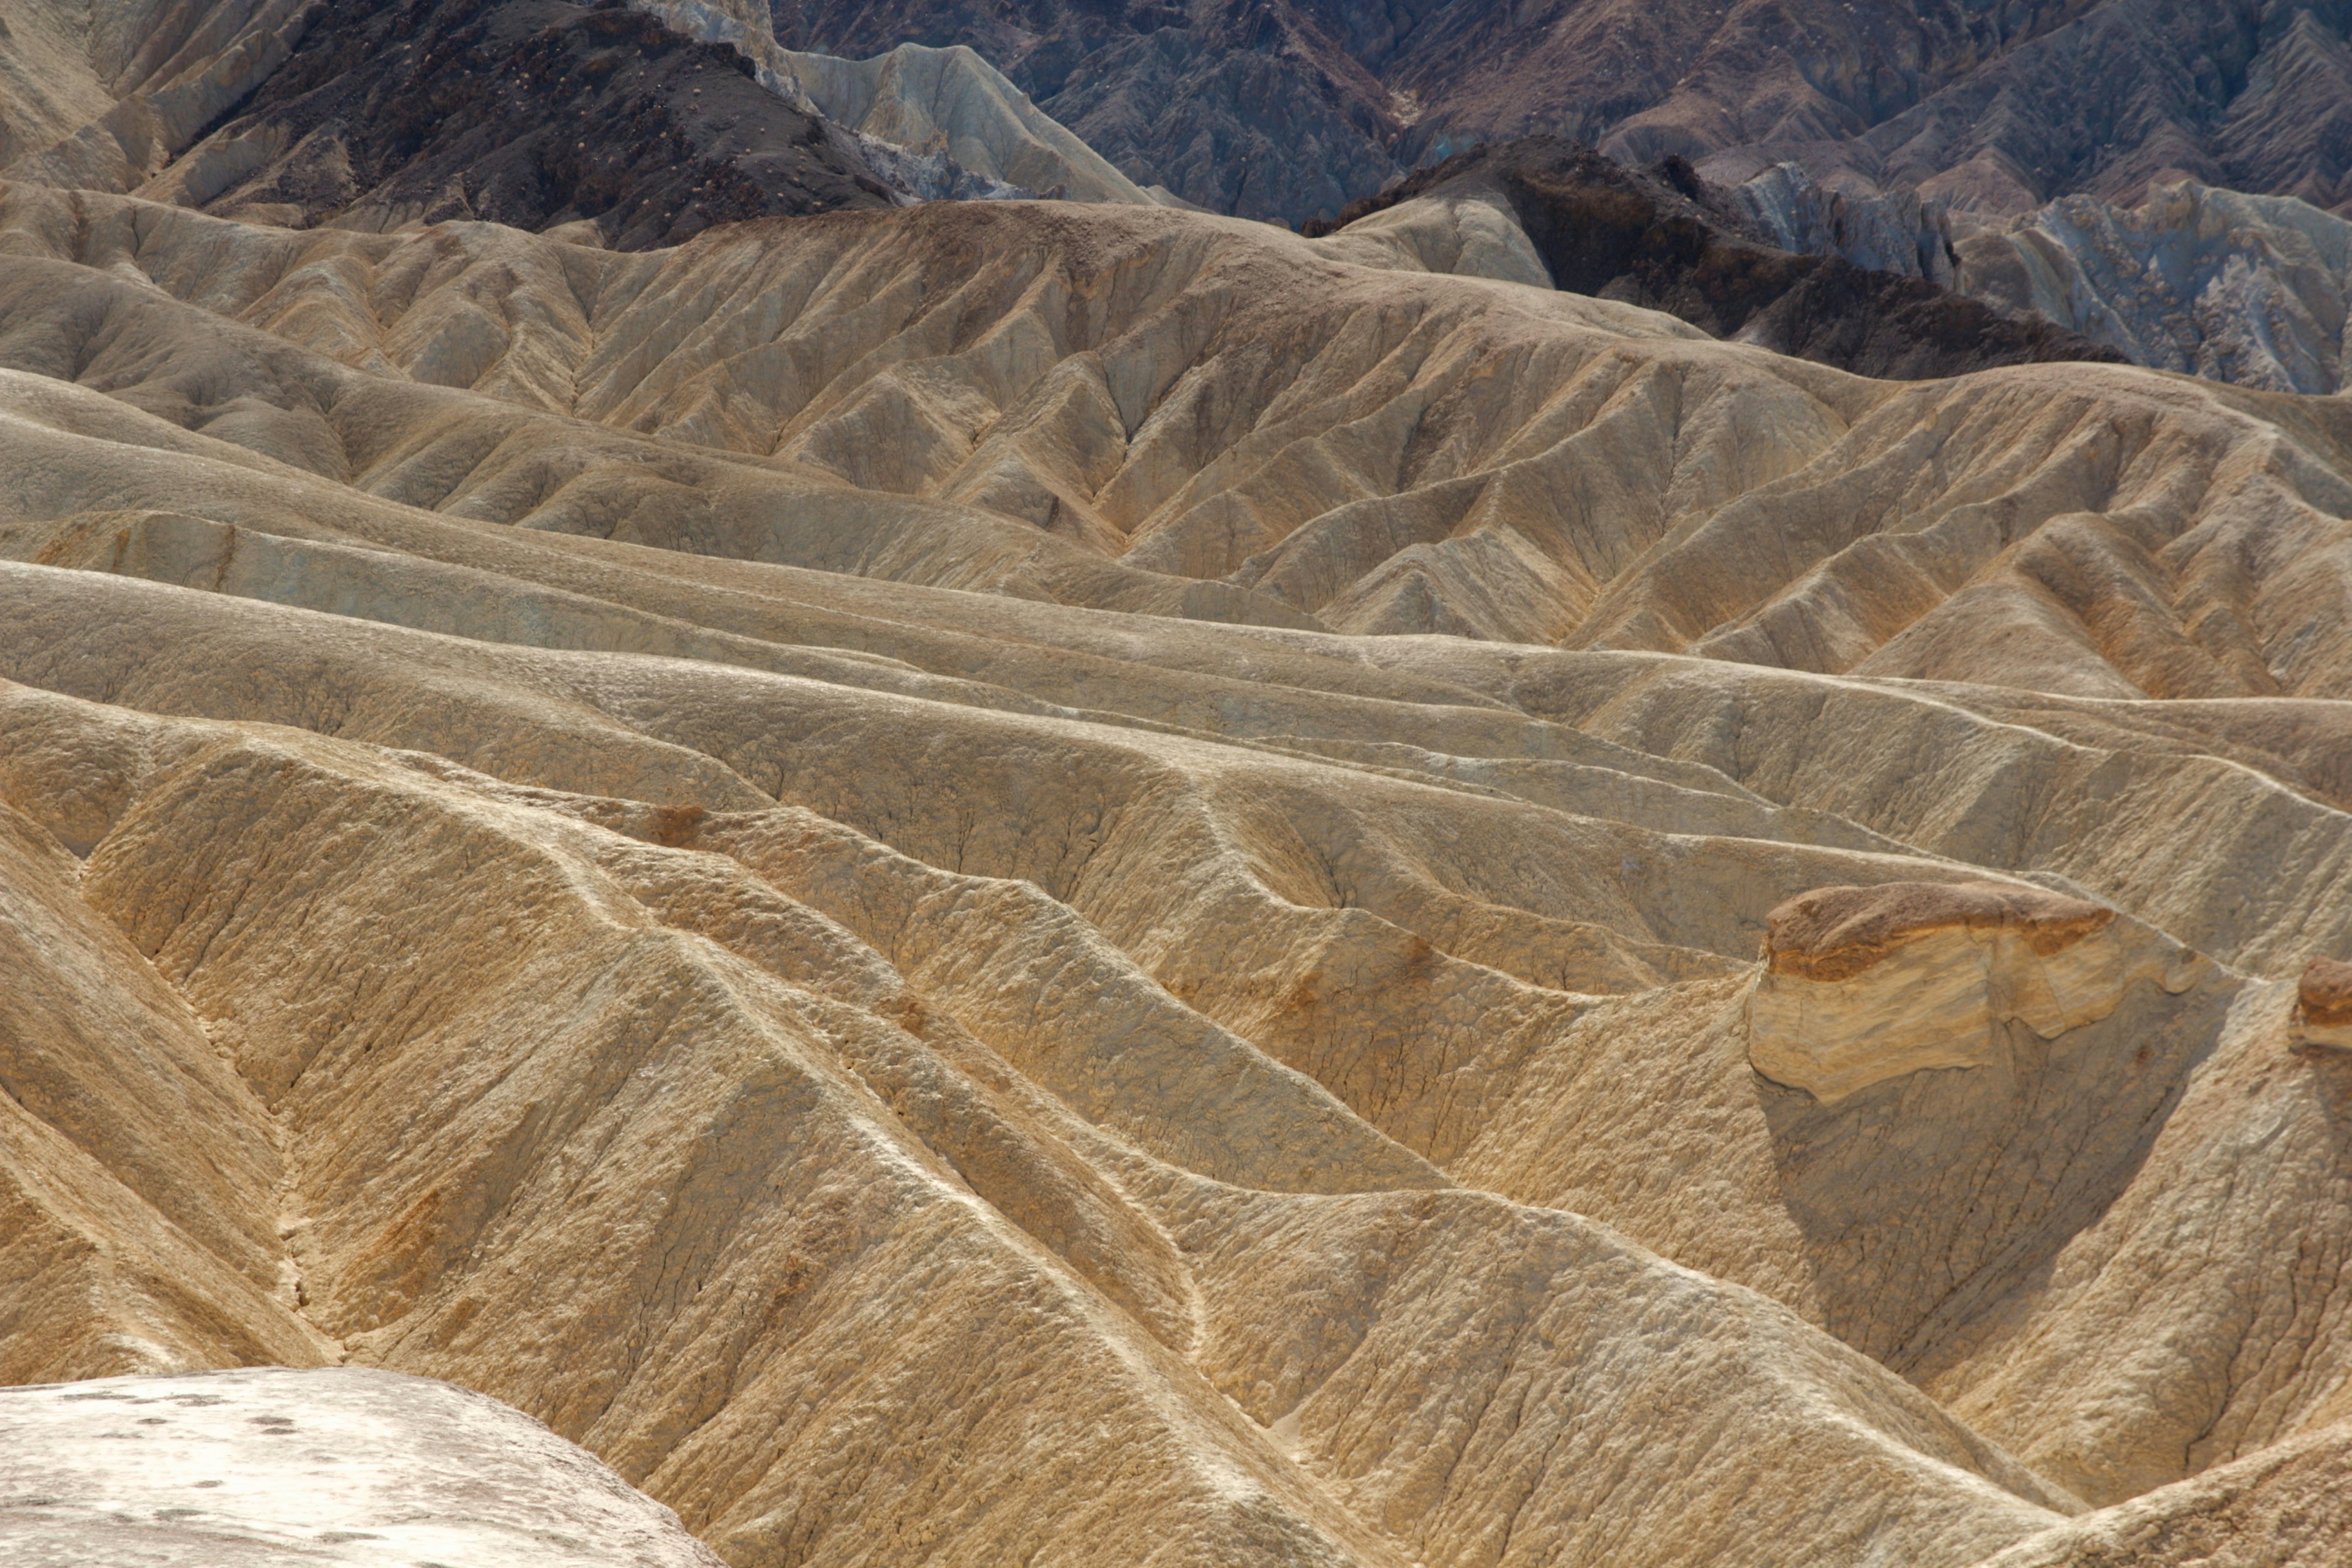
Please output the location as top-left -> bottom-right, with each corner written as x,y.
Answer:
0,1366 -> 720,1568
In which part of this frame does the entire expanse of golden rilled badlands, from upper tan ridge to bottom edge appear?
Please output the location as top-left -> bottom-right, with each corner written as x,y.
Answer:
0,175 -> 2352,1568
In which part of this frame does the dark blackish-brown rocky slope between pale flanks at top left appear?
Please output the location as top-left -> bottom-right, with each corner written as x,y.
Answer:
129,0 -> 891,249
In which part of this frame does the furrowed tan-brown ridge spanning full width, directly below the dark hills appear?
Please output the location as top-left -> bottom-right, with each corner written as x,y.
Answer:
0,186 -> 2352,682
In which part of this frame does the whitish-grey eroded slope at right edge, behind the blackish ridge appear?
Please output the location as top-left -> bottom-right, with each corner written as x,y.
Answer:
1959,181 -> 2352,395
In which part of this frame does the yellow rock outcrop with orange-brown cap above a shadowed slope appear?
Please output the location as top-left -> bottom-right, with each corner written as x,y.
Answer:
1747,881 -> 2204,1105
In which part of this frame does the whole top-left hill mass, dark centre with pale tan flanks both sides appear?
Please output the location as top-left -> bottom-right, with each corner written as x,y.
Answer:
0,0 -> 1176,249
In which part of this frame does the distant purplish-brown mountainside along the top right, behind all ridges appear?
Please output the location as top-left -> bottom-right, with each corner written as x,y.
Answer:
774,0 -> 2352,224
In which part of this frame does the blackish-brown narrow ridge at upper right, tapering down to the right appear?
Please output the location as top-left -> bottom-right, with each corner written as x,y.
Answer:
1303,137 -> 2124,381
